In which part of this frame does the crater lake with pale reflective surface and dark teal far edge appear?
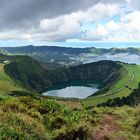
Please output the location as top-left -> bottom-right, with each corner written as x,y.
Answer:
42,80 -> 102,99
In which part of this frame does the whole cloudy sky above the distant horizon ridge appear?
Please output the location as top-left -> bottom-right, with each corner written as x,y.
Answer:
0,0 -> 140,47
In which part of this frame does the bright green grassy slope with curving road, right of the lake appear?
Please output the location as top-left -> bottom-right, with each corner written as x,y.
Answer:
82,64 -> 140,107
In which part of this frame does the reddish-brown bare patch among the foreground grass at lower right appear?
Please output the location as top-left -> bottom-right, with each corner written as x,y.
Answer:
95,114 -> 126,140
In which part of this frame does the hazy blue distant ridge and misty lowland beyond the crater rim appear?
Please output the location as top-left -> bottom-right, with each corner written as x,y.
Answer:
1,45 -> 140,65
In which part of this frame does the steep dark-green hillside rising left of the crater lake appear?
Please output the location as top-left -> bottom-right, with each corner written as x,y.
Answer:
4,56 -> 50,91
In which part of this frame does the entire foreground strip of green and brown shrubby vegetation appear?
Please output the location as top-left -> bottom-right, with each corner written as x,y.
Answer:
0,96 -> 140,140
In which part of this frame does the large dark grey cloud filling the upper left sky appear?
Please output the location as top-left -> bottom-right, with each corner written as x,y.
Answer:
0,0 -> 122,28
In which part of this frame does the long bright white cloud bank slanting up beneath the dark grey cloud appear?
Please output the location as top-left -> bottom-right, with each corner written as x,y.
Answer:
0,3 -> 119,41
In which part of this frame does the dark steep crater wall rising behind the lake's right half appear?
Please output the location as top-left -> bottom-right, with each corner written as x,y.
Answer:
68,61 -> 122,84
